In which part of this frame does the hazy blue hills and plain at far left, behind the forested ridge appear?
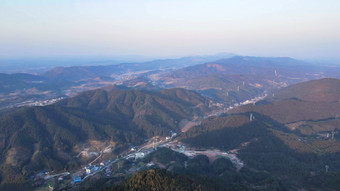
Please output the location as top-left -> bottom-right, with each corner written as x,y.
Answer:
0,53 -> 234,109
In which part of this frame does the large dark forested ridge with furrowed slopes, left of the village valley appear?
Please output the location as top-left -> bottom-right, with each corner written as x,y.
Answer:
0,89 -> 209,190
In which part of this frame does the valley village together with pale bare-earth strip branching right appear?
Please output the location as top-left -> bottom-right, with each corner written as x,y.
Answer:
31,129 -> 244,191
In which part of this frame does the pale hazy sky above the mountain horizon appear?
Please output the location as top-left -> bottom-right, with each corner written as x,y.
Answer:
0,0 -> 340,58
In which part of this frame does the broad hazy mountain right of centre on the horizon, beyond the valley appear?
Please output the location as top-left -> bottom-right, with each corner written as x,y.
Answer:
155,56 -> 340,103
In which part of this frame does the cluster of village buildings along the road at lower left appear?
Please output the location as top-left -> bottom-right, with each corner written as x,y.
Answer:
30,133 -> 177,191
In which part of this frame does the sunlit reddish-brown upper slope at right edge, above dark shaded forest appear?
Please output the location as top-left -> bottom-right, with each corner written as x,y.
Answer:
230,78 -> 340,127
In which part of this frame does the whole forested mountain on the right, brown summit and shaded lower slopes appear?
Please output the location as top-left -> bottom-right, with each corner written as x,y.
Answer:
181,79 -> 340,190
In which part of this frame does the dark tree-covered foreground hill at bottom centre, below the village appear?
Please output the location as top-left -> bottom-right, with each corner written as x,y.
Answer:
85,148 -> 287,191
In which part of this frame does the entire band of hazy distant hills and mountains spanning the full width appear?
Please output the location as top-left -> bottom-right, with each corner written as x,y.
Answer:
0,54 -> 340,108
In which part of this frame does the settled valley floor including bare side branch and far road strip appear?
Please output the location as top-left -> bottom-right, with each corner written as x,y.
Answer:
32,96 -> 258,190
